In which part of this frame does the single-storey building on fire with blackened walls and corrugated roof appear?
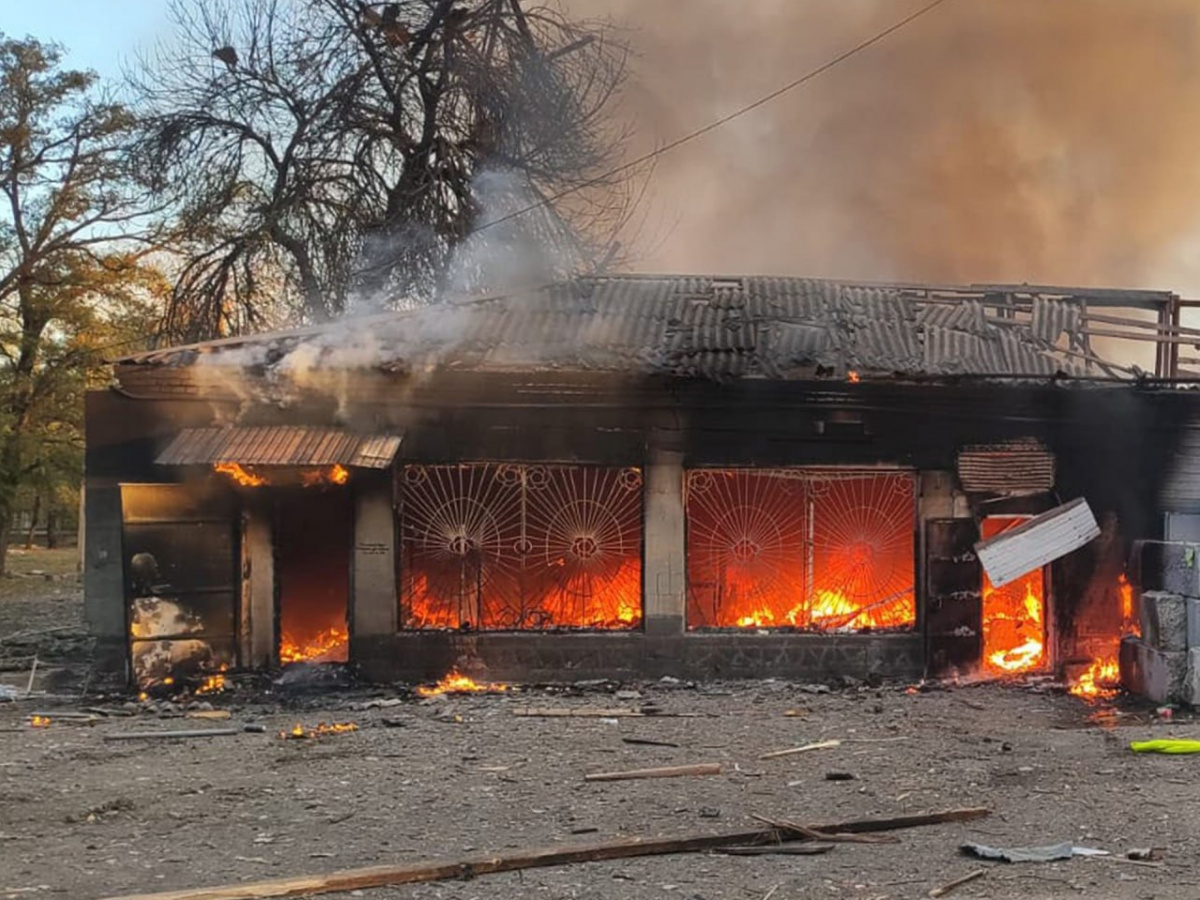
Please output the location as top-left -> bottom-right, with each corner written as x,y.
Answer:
85,276 -> 1200,683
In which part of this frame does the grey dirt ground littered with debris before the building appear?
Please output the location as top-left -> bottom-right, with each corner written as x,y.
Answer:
0,556 -> 1200,900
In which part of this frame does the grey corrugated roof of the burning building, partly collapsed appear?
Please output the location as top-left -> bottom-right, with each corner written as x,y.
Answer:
112,275 -> 1123,378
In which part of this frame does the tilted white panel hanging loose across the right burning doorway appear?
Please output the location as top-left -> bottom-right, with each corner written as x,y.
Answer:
976,497 -> 1100,588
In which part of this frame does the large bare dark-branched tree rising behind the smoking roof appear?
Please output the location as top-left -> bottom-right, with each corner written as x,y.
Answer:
133,0 -> 629,337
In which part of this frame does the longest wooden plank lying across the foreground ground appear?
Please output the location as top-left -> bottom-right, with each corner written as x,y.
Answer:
104,806 -> 991,900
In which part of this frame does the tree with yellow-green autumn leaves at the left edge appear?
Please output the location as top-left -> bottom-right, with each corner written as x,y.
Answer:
0,35 -> 162,572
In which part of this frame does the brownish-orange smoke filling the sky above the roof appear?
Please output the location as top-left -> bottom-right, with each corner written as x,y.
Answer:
568,0 -> 1200,295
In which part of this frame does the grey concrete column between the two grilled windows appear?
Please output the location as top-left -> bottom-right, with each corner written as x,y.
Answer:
642,449 -> 686,635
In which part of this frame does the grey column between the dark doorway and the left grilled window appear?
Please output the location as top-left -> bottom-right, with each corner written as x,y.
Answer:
350,478 -> 398,640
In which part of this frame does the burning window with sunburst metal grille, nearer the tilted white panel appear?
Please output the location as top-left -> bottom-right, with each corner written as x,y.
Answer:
685,469 -> 917,631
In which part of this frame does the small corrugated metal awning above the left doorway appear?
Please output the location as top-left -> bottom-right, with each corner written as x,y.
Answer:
155,425 -> 401,469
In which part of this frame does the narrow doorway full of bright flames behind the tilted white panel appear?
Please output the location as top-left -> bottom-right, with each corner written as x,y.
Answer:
980,516 -> 1046,676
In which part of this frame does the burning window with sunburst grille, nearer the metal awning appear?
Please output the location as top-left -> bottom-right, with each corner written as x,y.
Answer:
400,463 -> 642,630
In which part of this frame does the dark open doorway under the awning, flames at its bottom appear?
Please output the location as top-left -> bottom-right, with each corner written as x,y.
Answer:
272,487 -> 354,666
